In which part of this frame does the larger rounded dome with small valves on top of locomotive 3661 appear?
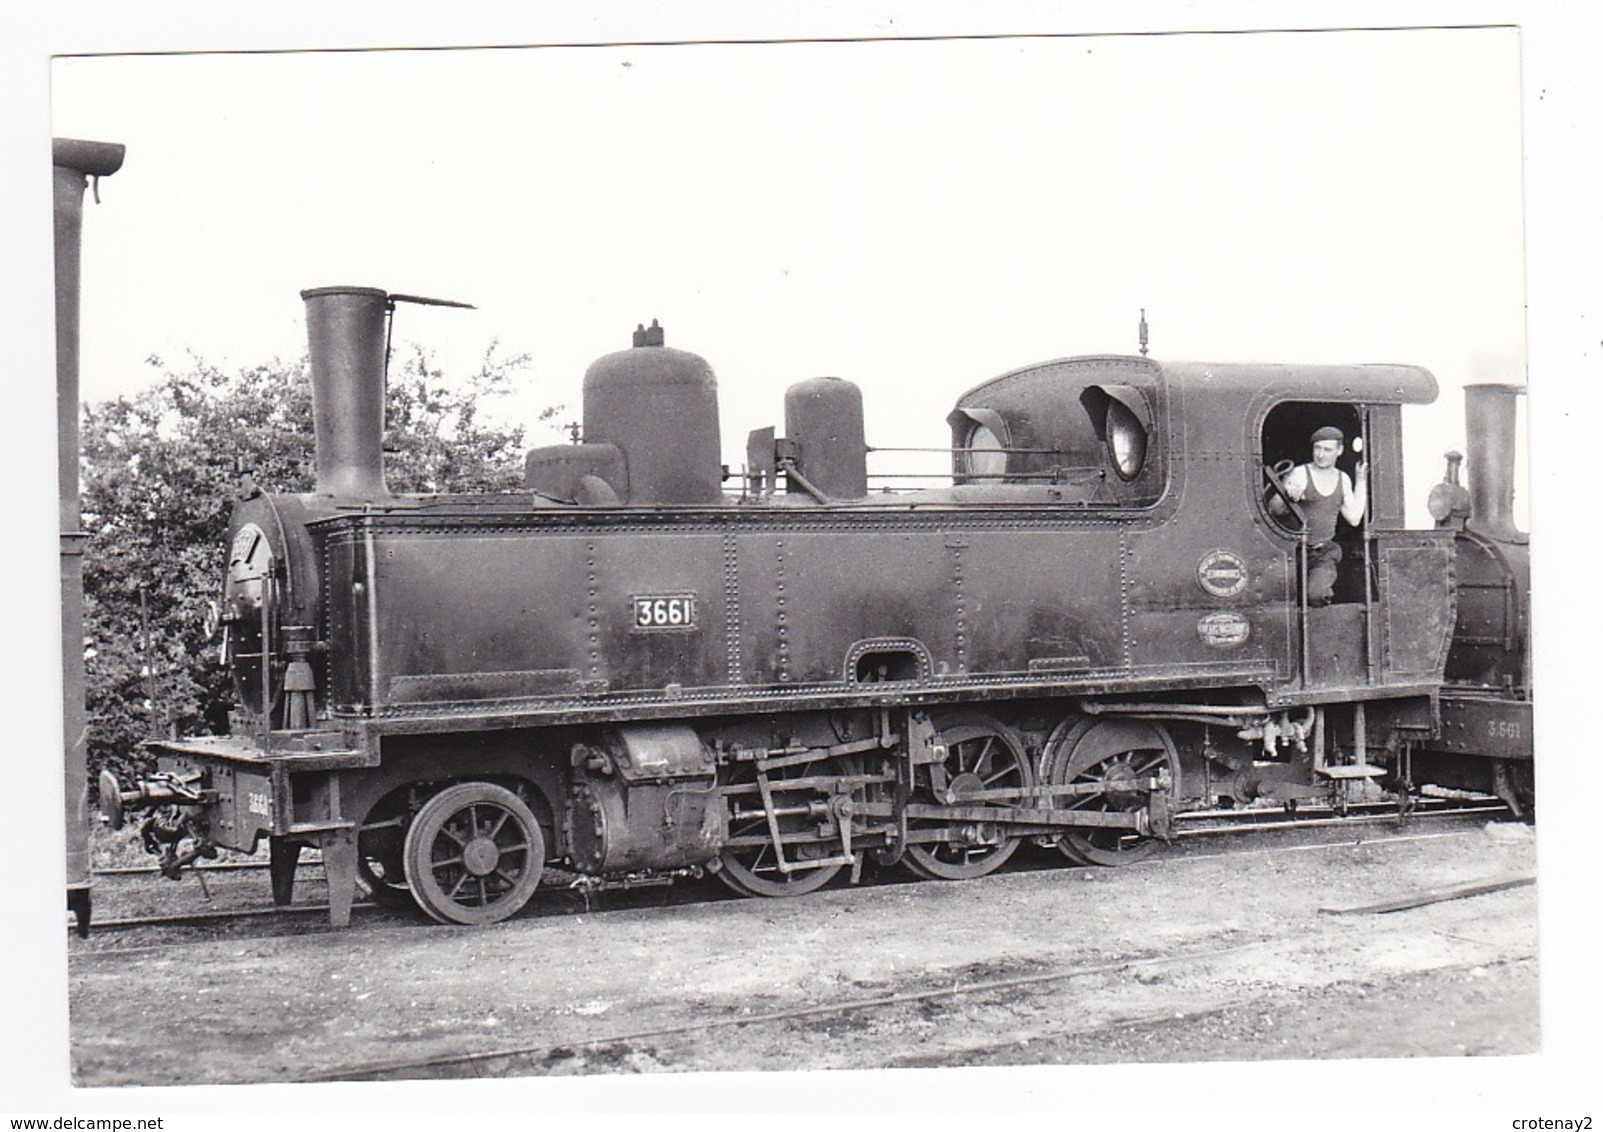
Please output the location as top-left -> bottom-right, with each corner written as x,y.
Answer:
583,322 -> 723,507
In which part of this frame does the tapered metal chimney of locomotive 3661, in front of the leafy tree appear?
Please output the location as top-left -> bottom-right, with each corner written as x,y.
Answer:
301,287 -> 391,499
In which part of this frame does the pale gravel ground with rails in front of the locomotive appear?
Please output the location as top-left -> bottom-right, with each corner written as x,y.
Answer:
69,823 -> 1540,1086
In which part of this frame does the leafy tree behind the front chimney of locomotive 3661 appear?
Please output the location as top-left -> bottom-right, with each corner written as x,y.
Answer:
80,346 -> 559,781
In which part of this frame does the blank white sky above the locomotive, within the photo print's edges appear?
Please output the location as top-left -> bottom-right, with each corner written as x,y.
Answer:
51,27 -> 1524,521
